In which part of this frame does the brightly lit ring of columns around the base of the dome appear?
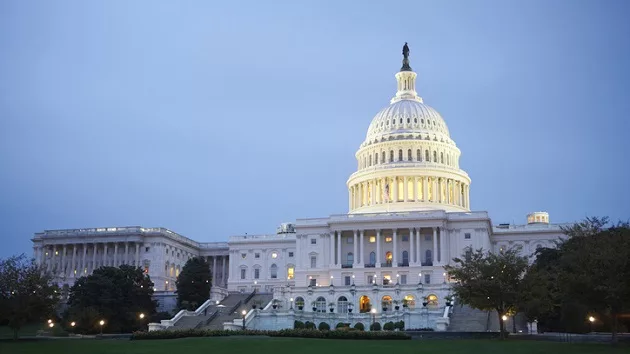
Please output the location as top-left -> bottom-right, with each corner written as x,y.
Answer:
349,176 -> 470,210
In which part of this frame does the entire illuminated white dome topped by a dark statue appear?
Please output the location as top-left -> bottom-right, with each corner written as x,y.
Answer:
347,43 -> 470,213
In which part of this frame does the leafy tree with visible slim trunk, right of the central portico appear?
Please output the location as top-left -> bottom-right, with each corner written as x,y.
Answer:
445,247 -> 527,338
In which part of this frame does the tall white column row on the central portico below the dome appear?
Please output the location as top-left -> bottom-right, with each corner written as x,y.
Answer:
329,227 -> 448,268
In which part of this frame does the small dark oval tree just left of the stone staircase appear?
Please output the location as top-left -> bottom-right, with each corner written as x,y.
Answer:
175,257 -> 212,310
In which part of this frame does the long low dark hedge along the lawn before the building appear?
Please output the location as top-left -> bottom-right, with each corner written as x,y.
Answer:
131,326 -> 411,340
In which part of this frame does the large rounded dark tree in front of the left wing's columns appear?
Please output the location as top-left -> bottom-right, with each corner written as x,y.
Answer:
64,265 -> 157,333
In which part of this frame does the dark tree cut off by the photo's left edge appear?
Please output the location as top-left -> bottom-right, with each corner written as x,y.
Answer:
0,254 -> 60,338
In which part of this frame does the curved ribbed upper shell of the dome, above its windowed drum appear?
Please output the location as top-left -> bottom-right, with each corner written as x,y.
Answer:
365,100 -> 452,144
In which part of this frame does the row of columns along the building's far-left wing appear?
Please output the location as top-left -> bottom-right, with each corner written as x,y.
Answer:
34,242 -> 142,277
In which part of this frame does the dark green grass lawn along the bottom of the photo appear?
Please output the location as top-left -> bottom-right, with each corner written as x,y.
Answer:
0,337 -> 628,354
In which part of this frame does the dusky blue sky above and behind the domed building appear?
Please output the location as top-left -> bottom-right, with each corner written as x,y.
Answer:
0,0 -> 630,257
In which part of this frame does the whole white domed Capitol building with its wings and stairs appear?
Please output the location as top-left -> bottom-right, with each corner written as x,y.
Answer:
33,45 -> 563,331
